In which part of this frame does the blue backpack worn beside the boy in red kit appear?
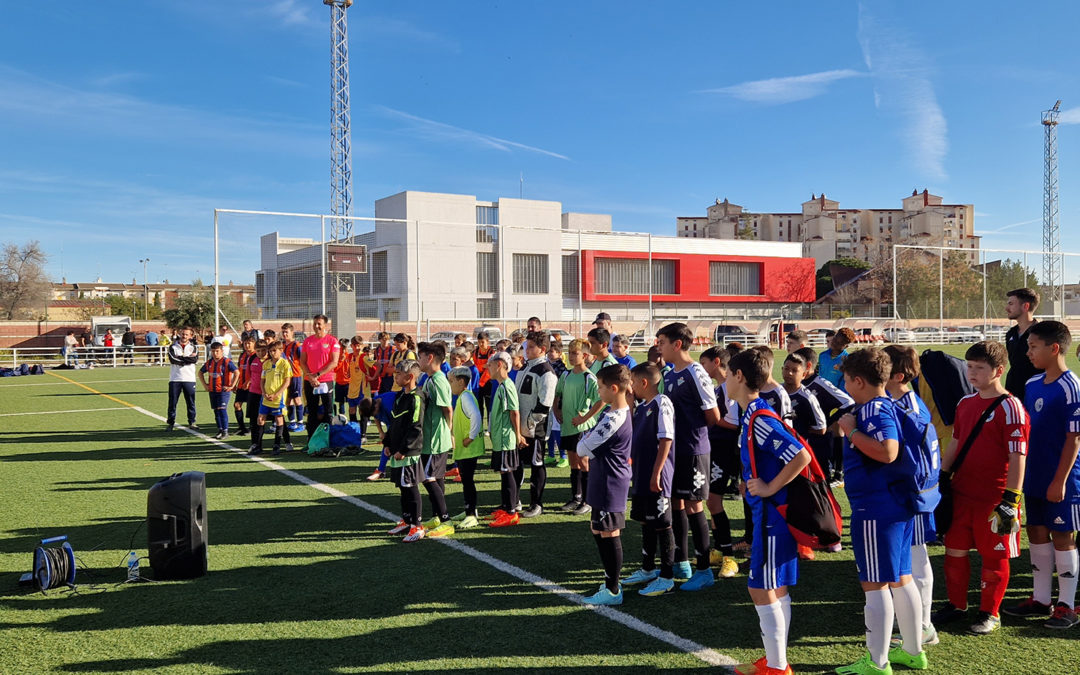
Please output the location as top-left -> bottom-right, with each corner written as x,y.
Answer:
887,406 -> 942,513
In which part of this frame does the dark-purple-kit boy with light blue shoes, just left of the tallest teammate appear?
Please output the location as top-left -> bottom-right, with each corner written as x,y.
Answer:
622,363 -> 675,596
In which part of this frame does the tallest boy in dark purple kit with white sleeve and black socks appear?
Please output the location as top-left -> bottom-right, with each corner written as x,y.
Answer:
657,323 -> 720,591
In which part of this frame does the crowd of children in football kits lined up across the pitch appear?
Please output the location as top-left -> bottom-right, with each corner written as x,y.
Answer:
183,298 -> 1080,675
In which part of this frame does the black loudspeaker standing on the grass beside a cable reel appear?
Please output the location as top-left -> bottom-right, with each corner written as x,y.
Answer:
146,471 -> 206,579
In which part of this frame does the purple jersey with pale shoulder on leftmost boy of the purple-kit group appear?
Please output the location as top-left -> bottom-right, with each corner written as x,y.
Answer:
578,407 -> 632,513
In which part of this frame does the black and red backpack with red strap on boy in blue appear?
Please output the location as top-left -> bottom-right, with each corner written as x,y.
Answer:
746,408 -> 843,548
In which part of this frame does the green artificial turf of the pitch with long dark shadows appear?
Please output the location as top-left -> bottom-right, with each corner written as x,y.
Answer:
0,348 -> 1080,673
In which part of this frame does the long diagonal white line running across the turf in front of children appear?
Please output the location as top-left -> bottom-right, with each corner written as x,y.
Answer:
122,406 -> 739,672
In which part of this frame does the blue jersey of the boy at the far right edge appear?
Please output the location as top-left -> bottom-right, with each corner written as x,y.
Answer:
1024,370 -> 1080,502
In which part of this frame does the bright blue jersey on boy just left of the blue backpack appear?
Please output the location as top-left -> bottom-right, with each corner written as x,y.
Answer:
843,396 -> 913,521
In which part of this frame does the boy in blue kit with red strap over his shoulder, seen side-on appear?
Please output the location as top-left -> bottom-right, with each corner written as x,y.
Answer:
727,349 -> 810,675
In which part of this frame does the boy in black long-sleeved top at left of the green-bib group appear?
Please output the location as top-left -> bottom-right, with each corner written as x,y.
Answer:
382,360 -> 424,543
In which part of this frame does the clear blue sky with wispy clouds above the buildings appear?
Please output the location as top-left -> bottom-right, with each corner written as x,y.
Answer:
0,0 -> 1080,282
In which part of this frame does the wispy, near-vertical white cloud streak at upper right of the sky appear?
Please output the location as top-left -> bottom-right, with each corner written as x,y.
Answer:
858,2 -> 948,179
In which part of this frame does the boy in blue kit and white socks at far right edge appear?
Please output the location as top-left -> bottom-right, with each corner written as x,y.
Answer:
1004,321 -> 1080,629
